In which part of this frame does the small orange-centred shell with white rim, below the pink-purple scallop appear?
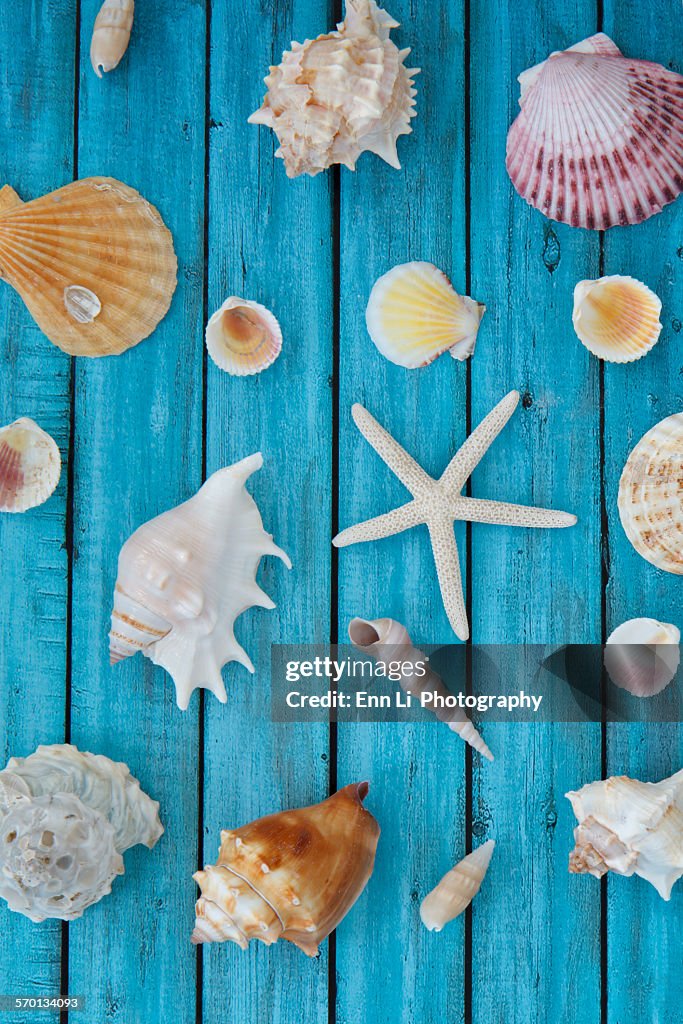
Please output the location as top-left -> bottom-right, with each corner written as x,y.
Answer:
572,275 -> 661,362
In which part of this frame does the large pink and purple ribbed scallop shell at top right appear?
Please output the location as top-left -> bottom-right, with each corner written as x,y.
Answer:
506,33 -> 683,230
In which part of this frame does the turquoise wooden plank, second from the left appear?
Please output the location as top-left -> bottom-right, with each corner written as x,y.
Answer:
69,0 -> 206,1024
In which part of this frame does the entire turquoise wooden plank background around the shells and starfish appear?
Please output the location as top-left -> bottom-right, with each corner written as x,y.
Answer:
0,0 -> 683,1024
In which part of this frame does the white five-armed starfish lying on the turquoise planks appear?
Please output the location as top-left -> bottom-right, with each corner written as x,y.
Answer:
332,391 -> 577,640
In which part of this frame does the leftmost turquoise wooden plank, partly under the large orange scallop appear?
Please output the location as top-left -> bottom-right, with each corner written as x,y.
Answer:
0,0 -> 75,1024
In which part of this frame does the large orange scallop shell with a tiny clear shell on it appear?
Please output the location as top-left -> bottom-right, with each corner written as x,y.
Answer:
0,178 -> 177,355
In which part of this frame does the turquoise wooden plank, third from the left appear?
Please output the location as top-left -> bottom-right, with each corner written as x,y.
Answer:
202,0 -> 333,1024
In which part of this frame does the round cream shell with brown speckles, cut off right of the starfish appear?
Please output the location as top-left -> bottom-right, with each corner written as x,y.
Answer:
617,413 -> 683,575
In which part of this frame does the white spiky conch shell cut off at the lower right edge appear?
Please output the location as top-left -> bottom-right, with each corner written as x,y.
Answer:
566,771 -> 683,900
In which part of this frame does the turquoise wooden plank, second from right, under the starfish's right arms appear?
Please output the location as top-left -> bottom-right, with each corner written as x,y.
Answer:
470,0 -> 600,1024
